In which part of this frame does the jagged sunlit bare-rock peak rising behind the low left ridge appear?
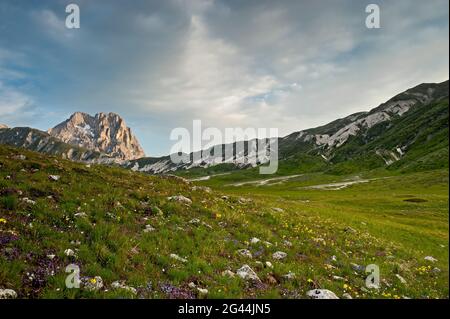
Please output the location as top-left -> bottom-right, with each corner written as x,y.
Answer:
47,112 -> 145,160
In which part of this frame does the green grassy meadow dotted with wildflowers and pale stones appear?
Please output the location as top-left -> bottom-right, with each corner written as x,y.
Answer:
0,146 -> 449,298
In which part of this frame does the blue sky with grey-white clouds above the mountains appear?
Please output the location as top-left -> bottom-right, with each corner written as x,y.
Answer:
0,0 -> 449,156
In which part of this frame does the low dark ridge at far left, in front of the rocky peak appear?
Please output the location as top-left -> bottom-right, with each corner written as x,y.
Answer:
0,127 -> 111,162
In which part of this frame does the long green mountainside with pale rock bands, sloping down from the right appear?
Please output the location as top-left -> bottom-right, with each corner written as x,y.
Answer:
124,81 -> 449,174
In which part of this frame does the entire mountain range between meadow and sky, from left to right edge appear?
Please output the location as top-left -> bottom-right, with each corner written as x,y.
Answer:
0,80 -> 449,174
